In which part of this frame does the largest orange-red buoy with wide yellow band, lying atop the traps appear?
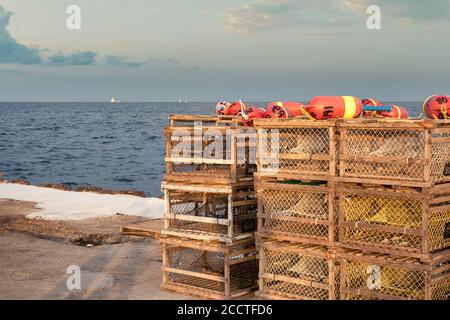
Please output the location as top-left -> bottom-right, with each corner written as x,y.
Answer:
305,96 -> 363,120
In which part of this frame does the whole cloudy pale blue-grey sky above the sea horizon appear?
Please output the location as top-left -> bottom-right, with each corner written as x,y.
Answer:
0,0 -> 450,102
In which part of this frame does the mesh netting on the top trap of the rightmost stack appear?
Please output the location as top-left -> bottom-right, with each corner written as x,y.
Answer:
341,129 -> 450,182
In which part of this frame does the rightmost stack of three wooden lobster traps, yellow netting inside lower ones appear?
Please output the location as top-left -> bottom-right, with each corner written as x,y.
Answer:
336,120 -> 450,300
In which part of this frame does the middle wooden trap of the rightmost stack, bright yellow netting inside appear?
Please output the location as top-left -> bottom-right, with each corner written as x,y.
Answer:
337,183 -> 450,261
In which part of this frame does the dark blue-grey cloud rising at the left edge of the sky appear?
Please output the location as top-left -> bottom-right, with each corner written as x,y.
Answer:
0,6 -> 42,64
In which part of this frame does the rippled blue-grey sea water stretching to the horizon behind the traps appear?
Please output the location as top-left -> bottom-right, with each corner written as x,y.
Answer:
0,102 -> 421,196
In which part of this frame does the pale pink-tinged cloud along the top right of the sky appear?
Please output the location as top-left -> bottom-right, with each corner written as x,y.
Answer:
224,0 -> 450,34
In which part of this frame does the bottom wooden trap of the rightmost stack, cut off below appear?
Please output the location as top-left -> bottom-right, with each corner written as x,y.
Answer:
338,250 -> 450,300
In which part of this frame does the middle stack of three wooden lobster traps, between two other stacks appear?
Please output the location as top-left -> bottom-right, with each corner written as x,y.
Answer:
254,118 -> 339,300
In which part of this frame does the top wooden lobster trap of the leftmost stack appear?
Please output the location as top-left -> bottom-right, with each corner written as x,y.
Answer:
164,126 -> 256,184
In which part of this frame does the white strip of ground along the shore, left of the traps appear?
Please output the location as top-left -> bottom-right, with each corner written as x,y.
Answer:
0,183 -> 164,220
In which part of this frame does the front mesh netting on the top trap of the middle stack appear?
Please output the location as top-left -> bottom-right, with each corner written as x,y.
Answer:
261,128 -> 330,174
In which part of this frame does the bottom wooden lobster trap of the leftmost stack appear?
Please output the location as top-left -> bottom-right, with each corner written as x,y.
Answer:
160,237 -> 258,299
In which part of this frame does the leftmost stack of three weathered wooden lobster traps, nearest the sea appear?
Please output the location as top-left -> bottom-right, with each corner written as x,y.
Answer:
160,115 -> 258,299
